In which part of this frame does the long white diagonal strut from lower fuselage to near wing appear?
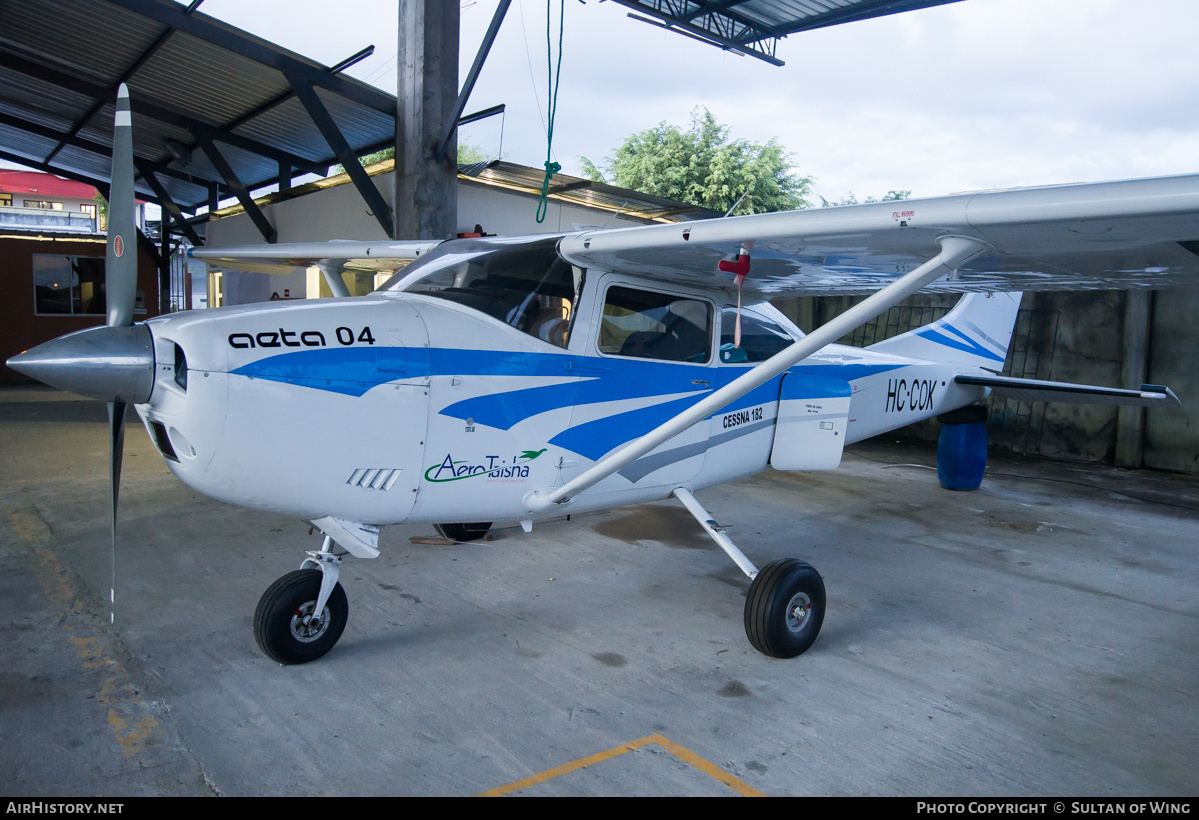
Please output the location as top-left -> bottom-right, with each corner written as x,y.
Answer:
524,236 -> 990,515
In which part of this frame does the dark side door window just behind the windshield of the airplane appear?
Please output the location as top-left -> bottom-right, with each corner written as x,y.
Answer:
600,287 -> 712,363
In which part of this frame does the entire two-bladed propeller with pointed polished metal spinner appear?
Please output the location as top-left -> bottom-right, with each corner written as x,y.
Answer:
7,83 -> 153,621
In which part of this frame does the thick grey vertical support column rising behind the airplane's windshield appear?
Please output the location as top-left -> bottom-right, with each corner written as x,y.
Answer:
394,0 -> 459,240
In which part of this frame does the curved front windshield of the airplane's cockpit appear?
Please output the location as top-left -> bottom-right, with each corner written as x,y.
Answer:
380,236 -> 583,348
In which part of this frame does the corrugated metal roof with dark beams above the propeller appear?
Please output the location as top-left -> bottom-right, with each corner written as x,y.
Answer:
0,0 -> 396,233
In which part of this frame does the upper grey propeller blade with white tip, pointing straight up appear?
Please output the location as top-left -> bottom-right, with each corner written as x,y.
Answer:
104,83 -> 138,327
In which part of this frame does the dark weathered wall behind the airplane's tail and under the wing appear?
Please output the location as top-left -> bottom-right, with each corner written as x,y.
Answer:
775,288 -> 1199,472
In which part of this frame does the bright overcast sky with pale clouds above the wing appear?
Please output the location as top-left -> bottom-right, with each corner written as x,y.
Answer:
14,0 -> 1199,205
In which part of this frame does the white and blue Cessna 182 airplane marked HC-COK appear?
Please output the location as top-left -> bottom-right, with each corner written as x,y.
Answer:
8,86 -> 1199,663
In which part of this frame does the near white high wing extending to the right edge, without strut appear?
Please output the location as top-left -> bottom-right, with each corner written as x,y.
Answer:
560,175 -> 1199,295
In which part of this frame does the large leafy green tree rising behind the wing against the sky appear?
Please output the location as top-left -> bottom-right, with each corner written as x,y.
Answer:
579,108 -> 812,213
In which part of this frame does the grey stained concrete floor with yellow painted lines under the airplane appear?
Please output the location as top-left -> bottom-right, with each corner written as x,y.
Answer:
0,387 -> 1199,796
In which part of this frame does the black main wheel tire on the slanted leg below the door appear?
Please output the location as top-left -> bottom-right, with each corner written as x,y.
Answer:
746,559 -> 825,658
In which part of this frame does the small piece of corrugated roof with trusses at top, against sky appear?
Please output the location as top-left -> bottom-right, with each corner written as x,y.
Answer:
616,0 -> 960,66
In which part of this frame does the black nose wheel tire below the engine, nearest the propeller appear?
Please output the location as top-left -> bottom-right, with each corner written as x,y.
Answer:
254,569 -> 350,664
